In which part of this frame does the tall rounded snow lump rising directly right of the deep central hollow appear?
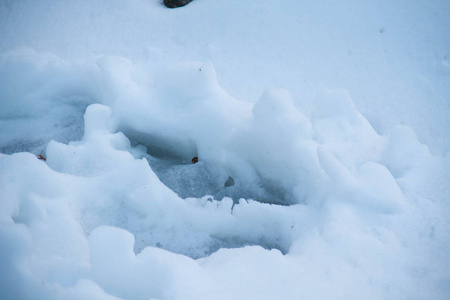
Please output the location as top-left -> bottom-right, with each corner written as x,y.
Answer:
227,89 -> 320,204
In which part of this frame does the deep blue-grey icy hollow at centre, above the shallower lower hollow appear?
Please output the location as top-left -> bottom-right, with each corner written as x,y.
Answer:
125,128 -> 297,205
